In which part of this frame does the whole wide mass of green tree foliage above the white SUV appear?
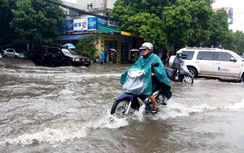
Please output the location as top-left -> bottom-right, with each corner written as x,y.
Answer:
109,0 -> 240,50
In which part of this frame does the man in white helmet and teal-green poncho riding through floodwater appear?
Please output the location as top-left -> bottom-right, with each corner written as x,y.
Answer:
120,42 -> 172,114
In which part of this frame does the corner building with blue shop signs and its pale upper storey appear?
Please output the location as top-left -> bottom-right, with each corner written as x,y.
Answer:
62,0 -> 142,63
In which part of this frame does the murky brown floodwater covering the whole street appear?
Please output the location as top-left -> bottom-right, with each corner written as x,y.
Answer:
0,59 -> 244,153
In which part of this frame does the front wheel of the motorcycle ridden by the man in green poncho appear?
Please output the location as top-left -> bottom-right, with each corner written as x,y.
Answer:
110,100 -> 134,118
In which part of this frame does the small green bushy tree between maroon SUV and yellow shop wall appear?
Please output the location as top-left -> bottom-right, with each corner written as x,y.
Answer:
75,34 -> 100,59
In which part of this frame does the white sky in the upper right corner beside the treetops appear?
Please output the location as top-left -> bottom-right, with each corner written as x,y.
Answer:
212,0 -> 244,32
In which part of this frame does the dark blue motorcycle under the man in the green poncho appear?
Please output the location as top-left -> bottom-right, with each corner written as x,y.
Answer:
110,63 -> 167,118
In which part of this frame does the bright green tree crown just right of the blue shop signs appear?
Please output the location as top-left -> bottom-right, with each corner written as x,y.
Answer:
109,0 -> 167,45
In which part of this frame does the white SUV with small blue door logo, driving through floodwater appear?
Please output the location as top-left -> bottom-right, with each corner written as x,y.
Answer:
169,47 -> 244,80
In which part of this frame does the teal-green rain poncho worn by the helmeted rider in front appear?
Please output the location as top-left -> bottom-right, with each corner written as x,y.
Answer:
120,53 -> 172,99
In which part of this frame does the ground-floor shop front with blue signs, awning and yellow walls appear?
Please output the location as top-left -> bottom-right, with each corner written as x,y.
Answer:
61,17 -> 142,63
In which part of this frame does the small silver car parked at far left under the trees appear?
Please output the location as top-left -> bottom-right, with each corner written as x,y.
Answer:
3,48 -> 29,59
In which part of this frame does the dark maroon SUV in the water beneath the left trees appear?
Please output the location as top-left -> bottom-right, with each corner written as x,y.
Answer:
31,45 -> 91,67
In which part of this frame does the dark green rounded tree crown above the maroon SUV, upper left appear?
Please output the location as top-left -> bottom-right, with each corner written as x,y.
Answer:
10,0 -> 65,44
